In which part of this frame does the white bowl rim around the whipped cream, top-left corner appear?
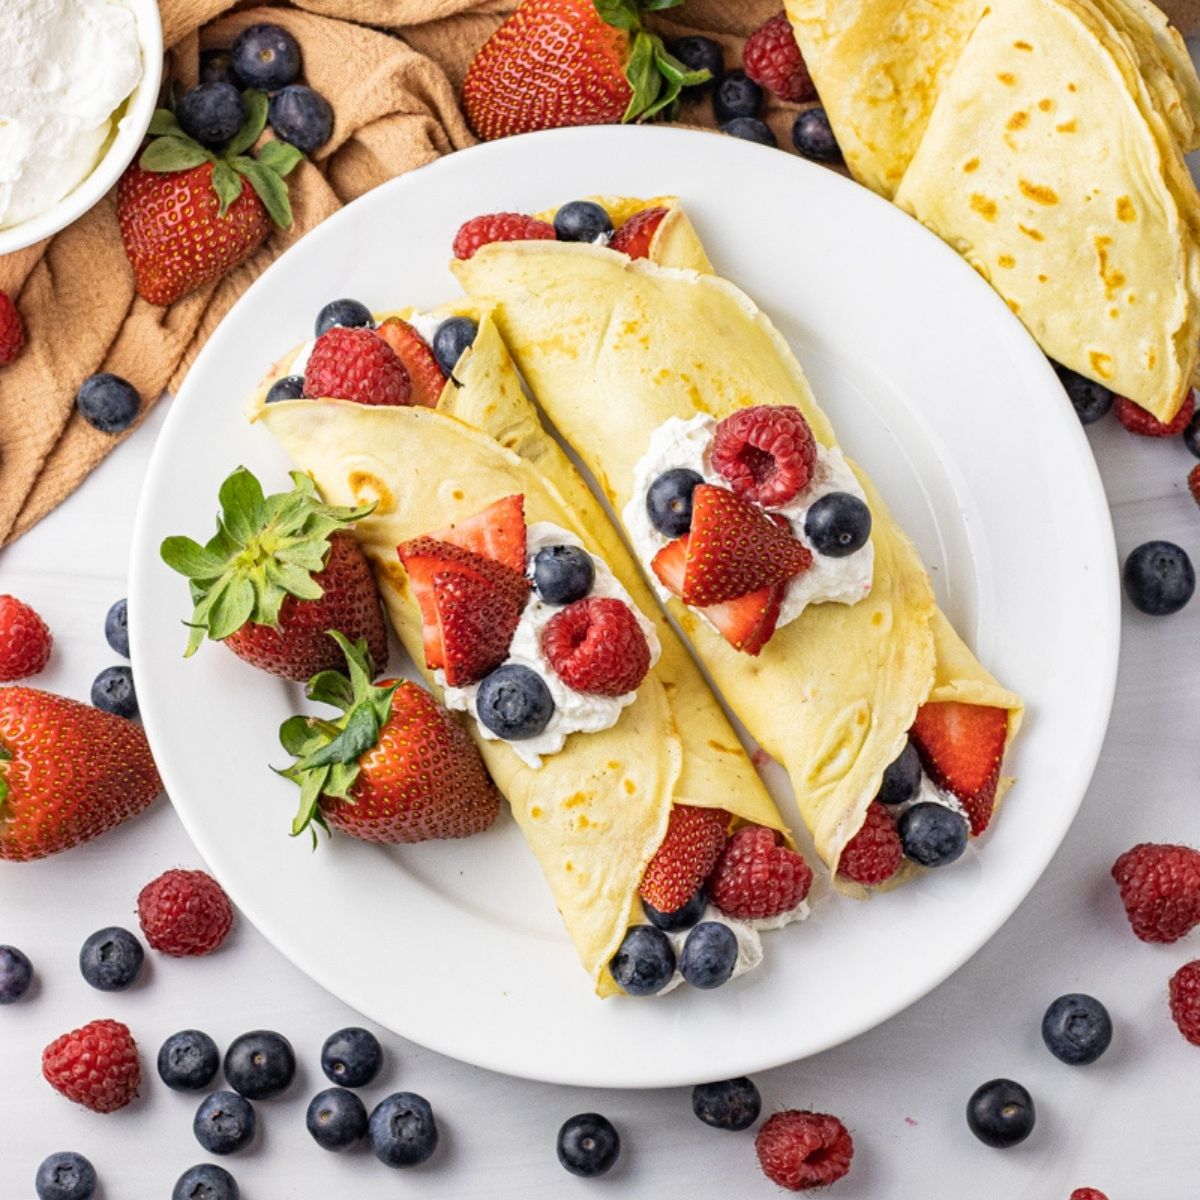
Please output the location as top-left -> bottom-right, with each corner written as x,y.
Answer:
0,0 -> 162,254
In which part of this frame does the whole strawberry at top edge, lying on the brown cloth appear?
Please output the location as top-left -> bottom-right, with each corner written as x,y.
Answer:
462,0 -> 712,140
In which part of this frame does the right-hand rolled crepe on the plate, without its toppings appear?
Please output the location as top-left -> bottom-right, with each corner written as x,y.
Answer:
452,198 -> 1021,893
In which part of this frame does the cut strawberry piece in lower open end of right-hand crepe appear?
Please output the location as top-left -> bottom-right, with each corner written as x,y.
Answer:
911,701 -> 1008,836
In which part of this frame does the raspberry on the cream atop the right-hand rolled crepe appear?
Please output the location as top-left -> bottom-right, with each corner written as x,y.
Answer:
712,404 -> 817,505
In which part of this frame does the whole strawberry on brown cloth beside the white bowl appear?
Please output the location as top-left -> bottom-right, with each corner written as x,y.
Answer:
116,91 -> 304,305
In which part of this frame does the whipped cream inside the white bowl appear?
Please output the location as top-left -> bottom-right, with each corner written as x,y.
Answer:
0,0 -> 143,229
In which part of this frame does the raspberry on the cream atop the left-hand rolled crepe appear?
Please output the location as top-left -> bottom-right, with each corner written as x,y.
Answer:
541,596 -> 650,696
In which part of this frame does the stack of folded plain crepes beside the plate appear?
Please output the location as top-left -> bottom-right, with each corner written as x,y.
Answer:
786,0 -> 1200,421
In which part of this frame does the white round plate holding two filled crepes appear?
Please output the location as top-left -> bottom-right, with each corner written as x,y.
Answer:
130,127 -> 1118,1087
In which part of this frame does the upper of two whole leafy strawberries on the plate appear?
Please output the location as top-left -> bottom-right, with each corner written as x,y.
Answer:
160,467 -> 388,680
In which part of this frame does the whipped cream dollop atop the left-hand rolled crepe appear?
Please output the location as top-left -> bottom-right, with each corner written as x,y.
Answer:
433,521 -> 661,767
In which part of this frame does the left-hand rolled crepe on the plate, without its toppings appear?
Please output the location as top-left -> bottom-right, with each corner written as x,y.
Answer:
250,306 -> 786,996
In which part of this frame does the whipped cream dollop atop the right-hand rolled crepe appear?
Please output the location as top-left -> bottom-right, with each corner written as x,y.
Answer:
622,413 -> 875,629
